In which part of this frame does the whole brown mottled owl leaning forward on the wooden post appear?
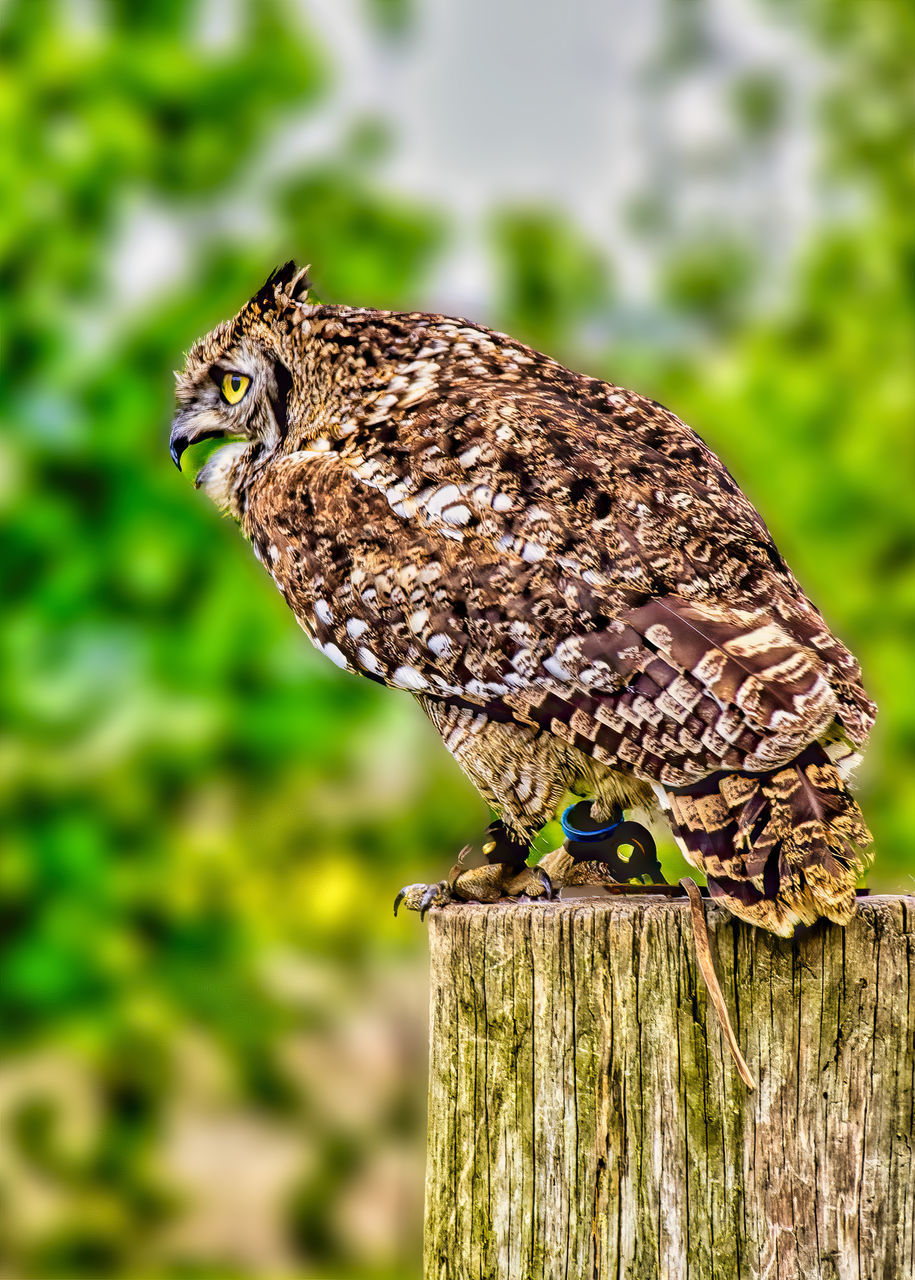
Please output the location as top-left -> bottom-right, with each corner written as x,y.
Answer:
170,262 -> 875,934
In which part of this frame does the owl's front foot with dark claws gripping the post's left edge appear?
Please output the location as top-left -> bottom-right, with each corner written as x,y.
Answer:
394,822 -> 554,919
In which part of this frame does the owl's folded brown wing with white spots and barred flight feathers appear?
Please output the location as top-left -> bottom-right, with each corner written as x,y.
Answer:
246,380 -> 871,786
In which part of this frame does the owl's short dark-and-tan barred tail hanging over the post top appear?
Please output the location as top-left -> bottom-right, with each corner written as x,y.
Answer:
665,742 -> 873,937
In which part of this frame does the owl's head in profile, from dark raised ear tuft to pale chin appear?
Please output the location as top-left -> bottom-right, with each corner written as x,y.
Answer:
169,262 -> 308,509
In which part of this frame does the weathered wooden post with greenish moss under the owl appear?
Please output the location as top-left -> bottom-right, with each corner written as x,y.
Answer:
425,896 -> 915,1280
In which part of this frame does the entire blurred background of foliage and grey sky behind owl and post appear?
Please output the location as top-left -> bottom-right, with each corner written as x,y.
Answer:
0,0 -> 915,1280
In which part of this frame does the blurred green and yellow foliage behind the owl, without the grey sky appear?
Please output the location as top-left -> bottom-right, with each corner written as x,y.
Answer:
0,0 -> 915,1276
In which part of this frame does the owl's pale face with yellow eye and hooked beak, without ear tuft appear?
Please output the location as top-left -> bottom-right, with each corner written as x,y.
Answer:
169,324 -> 292,509
